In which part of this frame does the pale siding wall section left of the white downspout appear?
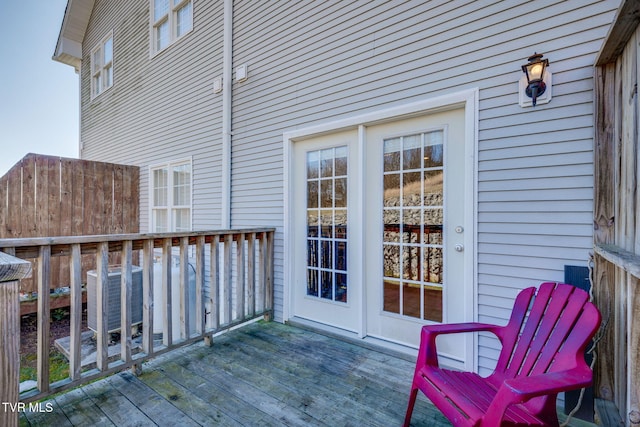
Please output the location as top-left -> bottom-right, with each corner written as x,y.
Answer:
80,0 -> 223,232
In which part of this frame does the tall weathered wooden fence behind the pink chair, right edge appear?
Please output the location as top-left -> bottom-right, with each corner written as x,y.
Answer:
593,0 -> 640,425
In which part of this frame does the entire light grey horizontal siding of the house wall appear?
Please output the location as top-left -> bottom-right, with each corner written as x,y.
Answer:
81,0 -> 619,373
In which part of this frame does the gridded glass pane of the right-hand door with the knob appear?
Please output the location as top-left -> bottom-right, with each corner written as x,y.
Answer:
382,130 -> 444,322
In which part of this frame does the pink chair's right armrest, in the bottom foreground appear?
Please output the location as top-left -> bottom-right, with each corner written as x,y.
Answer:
482,366 -> 593,426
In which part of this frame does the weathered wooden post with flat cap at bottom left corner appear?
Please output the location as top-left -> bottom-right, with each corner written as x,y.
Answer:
0,252 -> 31,427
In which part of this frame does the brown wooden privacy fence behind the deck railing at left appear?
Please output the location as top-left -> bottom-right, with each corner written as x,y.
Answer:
0,154 -> 140,304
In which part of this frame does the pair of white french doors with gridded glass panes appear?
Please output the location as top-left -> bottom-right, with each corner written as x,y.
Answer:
290,104 -> 473,366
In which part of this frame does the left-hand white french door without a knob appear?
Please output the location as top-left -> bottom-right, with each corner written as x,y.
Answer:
293,130 -> 362,332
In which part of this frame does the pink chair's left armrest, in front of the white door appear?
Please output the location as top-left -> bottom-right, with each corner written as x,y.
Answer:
417,322 -> 504,367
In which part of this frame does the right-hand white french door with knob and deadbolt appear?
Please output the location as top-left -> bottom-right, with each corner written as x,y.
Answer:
363,109 -> 472,365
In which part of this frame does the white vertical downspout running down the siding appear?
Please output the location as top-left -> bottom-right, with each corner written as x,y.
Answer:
220,0 -> 233,230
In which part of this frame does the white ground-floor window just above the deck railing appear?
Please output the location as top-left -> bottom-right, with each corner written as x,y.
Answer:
150,161 -> 191,233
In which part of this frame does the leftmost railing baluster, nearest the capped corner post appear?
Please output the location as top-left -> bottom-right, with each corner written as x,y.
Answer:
38,245 -> 51,392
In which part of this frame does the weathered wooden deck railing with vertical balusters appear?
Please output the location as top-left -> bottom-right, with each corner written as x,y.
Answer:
0,228 -> 274,422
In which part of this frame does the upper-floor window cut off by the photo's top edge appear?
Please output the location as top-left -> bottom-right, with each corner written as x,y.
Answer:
151,0 -> 193,53
